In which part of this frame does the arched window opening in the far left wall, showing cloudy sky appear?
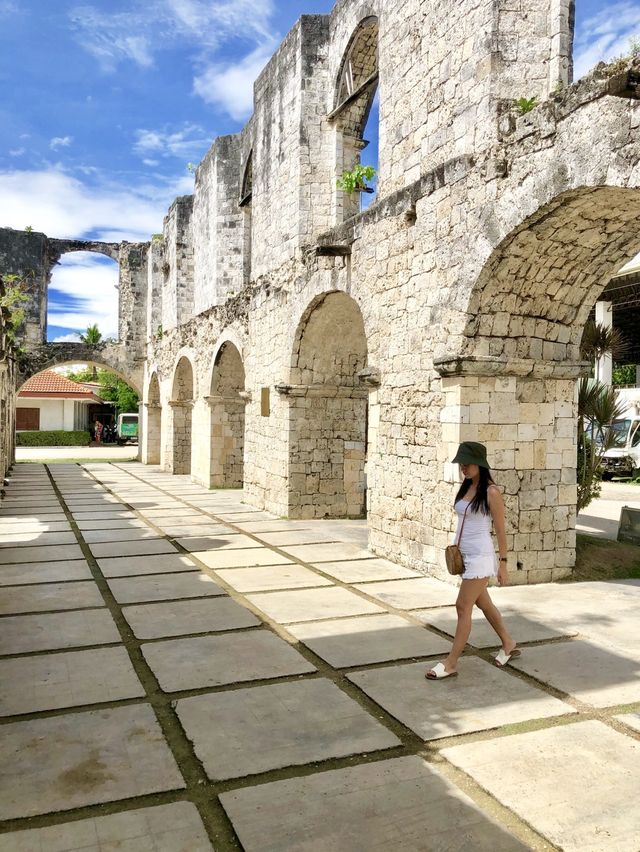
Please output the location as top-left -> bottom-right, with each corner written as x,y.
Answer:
47,251 -> 119,343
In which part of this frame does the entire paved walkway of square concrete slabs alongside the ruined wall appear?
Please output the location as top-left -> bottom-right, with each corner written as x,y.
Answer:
0,463 -> 640,852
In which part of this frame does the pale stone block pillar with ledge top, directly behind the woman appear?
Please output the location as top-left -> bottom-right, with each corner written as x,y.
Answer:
434,362 -> 583,583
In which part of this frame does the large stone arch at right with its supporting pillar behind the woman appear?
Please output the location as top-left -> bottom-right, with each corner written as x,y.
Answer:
436,186 -> 640,582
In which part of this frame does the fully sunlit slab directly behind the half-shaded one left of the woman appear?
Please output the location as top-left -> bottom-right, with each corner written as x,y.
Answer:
247,587 -> 383,624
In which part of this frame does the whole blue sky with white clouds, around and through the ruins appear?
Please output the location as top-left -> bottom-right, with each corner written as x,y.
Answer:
0,0 -> 640,339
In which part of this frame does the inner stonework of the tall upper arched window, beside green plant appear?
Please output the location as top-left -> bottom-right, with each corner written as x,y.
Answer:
331,14 -> 379,221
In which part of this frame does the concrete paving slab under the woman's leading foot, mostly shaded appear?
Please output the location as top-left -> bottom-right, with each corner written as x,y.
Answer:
347,658 -> 575,740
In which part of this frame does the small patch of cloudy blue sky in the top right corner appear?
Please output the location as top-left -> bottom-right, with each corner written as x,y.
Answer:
574,0 -> 640,80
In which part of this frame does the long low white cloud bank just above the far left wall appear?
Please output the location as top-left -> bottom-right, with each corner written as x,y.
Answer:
0,168 -> 193,242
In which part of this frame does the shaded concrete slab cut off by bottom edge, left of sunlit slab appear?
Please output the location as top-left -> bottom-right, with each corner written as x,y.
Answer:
220,757 -> 529,852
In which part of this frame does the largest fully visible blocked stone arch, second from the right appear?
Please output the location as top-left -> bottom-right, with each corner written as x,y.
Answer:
281,291 -> 369,518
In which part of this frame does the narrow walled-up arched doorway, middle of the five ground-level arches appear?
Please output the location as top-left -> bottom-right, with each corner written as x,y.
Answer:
207,342 -> 246,488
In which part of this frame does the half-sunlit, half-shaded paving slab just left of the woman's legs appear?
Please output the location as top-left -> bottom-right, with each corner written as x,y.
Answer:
287,614 -> 451,668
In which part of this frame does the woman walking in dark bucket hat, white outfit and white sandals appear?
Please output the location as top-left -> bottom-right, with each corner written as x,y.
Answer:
425,441 -> 520,680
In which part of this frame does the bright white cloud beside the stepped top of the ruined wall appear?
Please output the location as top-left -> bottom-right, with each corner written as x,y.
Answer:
193,41 -> 274,121
